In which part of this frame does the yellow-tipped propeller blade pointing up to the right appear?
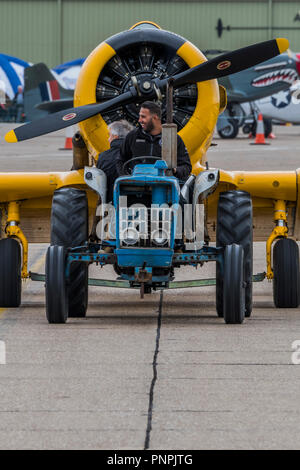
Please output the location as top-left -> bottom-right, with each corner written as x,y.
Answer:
170,38 -> 289,87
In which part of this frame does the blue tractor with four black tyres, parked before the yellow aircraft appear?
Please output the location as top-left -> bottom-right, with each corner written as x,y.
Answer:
45,136 -> 252,323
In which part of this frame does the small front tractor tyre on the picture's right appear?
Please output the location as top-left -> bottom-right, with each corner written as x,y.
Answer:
223,244 -> 245,323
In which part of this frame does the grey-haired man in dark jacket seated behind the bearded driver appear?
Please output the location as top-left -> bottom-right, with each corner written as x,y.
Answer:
97,120 -> 133,202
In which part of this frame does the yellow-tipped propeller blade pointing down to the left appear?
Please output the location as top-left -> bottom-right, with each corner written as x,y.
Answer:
5,88 -> 136,142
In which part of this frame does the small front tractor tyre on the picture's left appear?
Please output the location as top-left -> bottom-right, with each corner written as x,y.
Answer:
46,245 -> 68,323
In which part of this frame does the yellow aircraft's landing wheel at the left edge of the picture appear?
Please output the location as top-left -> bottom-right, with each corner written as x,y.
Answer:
0,238 -> 22,308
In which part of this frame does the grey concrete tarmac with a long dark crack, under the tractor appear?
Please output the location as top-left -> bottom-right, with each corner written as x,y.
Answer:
0,124 -> 300,450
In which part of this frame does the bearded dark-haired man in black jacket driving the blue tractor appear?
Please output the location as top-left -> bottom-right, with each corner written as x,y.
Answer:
117,101 -> 192,180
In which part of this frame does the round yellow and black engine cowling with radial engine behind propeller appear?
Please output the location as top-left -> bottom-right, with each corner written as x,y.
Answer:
74,22 -> 220,173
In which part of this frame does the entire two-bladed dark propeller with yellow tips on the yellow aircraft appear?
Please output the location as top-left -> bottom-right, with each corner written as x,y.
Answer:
5,38 -> 289,142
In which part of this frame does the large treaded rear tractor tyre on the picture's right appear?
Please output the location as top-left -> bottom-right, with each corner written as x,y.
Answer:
216,191 -> 253,317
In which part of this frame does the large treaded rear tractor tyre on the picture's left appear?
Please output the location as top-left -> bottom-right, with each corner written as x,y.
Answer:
51,187 -> 88,317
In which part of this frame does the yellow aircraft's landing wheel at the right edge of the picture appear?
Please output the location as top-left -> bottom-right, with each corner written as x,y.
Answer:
273,238 -> 300,308
